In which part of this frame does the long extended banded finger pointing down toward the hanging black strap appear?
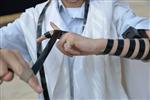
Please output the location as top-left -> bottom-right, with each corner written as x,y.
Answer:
3,51 -> 41,93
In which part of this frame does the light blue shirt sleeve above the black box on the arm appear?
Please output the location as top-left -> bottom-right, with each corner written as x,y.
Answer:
113,0 -> 150,36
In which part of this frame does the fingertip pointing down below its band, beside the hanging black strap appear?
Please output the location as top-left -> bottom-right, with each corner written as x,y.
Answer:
28,75 -> 43,93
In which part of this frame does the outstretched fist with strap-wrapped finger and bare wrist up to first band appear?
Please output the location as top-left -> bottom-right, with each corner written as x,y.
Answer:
37,22 -> 106,56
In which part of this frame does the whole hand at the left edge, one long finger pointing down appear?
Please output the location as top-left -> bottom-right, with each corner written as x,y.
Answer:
0,49 -> 43,93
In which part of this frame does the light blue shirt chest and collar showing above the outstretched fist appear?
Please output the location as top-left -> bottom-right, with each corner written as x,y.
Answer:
59,0 -> 85,33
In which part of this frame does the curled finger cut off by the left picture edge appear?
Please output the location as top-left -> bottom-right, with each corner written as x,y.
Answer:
0,59 -> 8,78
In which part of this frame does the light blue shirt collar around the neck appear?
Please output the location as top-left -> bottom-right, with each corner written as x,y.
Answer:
58,0 -> 85,19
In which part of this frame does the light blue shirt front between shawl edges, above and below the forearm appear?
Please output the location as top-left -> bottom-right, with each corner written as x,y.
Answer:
59,0 -> 85,96
